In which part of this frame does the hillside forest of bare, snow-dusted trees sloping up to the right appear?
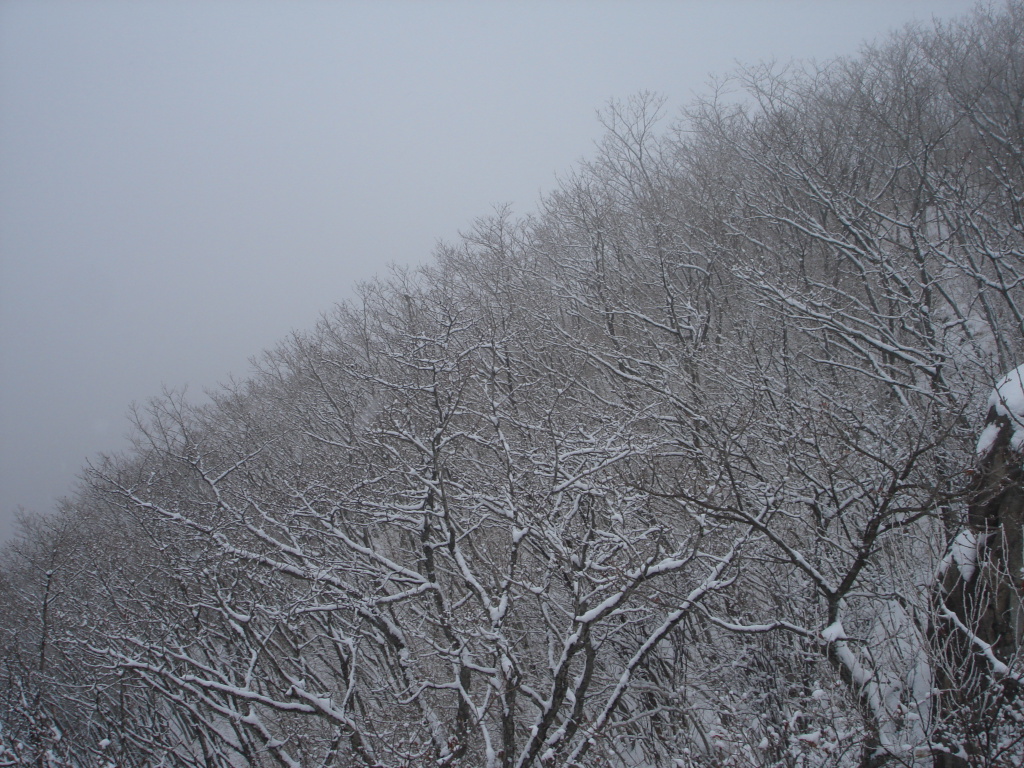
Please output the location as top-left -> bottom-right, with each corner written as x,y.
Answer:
0,0 -> 1024,768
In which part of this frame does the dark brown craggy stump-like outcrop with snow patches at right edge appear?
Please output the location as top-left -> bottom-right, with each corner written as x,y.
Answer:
931,406 -> 1024,768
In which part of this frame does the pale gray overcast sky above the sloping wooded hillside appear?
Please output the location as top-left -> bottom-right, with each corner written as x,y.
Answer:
0,0 -> 973,540
